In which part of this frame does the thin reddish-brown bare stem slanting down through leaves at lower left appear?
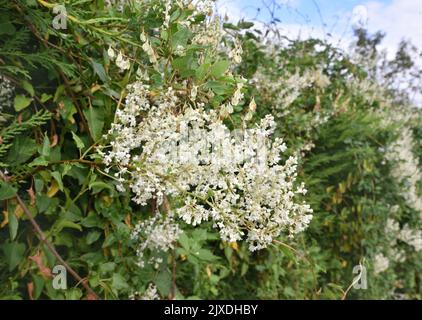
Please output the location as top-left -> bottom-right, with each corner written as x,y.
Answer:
0,171 -> 100,300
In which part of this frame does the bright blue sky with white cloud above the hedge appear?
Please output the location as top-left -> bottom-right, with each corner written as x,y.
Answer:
217,0 -> 422,52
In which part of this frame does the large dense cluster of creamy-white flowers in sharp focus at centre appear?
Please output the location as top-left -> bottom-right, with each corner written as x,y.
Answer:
104,82 -> 312,251
